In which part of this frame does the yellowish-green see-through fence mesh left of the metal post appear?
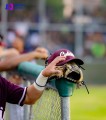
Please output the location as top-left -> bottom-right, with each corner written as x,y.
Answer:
30,88 -> 61,120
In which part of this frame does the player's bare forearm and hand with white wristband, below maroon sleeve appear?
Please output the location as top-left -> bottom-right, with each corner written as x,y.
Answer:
24,56 -> 65,104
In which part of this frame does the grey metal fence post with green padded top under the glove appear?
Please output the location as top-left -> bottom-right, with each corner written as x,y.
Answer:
56,79 -> 75,120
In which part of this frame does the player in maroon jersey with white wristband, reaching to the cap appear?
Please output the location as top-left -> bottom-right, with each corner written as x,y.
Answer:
0,56 -> 66,120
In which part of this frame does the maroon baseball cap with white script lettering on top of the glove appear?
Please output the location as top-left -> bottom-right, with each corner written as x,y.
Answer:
48,49 -> 84,66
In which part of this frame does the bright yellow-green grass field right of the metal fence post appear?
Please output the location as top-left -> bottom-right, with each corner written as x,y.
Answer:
70,86 -> 106,120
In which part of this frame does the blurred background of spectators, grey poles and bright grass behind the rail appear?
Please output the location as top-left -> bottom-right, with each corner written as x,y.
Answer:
0,0 -> 106,120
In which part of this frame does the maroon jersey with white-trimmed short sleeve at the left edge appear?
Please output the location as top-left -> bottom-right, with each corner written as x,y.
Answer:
0,76 -> 26,120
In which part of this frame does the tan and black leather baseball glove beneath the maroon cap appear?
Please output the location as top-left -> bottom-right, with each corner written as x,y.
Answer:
49,62 -> 89,94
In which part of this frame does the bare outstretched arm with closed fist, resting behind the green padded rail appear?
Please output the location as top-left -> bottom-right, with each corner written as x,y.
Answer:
0,49 -> 48,72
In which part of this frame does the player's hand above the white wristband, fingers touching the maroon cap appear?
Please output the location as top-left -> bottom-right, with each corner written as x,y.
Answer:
42,56 -> 66,77
